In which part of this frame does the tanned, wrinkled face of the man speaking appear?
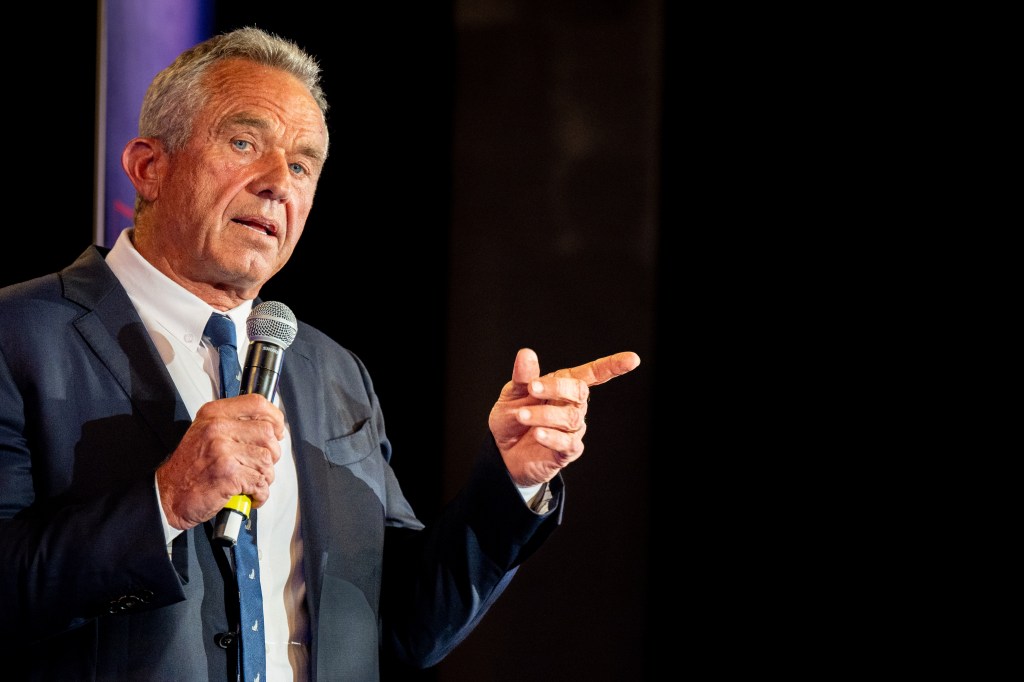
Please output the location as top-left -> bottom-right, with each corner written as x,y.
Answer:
148,59 -> 327,298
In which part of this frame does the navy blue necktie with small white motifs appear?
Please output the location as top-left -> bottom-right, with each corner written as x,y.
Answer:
205,313 -> 266,682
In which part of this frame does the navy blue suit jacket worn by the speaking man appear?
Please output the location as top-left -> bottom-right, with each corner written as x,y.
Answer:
0,247 -> 563,682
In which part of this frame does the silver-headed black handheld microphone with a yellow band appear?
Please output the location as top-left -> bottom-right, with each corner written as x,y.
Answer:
213,301 -> 299,546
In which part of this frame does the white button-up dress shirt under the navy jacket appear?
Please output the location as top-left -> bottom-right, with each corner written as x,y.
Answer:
106,227 -> 309,682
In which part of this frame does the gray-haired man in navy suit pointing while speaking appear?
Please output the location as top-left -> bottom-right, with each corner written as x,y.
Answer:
0,28 -> 640,682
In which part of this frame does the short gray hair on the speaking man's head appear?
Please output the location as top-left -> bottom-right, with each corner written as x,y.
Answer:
138,27 -> 328,154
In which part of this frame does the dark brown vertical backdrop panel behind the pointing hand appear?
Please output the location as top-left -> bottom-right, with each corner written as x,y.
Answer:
440,0 -> 659,682
